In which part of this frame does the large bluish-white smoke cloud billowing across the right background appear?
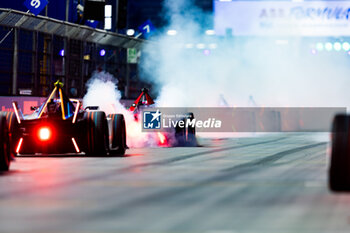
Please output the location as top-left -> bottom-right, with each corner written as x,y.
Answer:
140,0 -> 350,107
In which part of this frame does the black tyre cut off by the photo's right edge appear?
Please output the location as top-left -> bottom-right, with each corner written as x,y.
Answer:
329,114 -> 350,192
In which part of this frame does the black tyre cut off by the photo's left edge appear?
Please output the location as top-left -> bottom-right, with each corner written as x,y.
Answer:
0,115 -> 11,171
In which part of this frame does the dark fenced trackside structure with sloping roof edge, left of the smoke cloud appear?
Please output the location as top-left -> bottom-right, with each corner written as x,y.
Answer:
0,8 -> 150,98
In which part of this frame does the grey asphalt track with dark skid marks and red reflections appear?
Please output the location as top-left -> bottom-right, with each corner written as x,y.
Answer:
0,134 -> 350,233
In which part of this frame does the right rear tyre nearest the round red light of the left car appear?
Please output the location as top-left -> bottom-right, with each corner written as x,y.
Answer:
84,111 -> 108,156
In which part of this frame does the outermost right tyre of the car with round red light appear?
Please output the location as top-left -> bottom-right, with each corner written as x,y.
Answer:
108,114 -> 127,155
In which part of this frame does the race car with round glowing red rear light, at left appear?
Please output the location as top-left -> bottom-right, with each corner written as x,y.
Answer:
0,81 -> 127,170
